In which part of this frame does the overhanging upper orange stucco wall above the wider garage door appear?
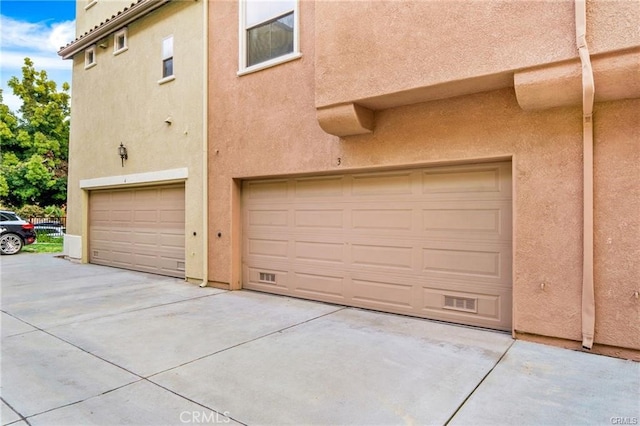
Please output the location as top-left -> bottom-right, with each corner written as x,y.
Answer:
316,0 -> 640,109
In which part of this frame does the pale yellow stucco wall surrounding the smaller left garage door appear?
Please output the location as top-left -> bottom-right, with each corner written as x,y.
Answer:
67,2 -> 205,278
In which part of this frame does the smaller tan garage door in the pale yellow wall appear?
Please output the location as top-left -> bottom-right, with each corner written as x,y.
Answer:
89,185 -> 185,277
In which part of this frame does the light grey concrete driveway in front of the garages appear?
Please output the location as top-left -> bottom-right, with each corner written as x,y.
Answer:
0,253 -> 640,425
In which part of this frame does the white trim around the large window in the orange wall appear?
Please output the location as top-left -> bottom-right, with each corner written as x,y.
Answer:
236,0 -> 302,76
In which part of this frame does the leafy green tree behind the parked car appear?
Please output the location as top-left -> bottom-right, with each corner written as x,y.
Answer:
0,58 -> 70,208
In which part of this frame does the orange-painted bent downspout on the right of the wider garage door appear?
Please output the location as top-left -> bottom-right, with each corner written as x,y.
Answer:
575,0 -> 595,350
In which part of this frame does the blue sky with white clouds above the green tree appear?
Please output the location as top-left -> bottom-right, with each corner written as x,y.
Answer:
0,0 -> 76,111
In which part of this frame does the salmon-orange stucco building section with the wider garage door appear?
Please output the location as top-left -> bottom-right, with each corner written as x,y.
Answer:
208,0 -> 640,359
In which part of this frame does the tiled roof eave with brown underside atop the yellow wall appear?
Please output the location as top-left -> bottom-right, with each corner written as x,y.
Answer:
58,0 -> 171,59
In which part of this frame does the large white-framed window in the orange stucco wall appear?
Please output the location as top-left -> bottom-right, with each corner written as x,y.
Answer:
240,0 -> 300,73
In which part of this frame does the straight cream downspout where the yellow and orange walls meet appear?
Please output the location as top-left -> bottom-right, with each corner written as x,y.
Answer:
200,0 -> 209,287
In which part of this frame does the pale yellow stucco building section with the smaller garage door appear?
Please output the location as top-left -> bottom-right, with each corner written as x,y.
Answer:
60,0 -> 207,281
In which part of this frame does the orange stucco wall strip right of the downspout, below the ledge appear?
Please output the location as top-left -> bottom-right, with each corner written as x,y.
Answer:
594,99 -> 640,348
